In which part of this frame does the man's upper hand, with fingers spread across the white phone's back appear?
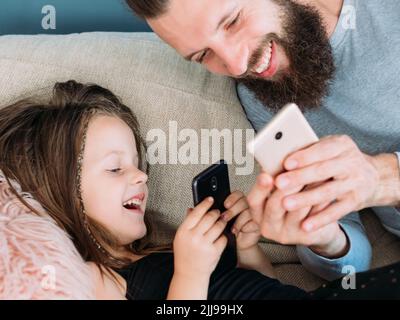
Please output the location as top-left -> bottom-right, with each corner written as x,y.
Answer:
275,136 -> 400,231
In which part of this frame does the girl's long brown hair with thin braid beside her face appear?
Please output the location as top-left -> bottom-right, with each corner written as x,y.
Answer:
0,80 -> 165,269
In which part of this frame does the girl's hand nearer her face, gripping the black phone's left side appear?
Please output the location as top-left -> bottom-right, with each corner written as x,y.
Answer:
173,197 -> 227,279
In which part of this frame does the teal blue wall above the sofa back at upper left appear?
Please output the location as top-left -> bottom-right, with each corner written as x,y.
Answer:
0,0 -> 150,35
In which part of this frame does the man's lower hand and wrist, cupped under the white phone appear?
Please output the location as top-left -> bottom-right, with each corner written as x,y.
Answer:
247,173 -> 348,258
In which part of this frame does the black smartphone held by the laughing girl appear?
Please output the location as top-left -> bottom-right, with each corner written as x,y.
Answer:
192,160 -> 236,246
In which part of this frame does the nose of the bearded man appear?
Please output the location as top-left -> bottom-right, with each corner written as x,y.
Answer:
218,44 -> 249,77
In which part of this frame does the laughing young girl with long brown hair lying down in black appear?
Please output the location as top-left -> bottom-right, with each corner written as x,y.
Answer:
0,81 -> 400,299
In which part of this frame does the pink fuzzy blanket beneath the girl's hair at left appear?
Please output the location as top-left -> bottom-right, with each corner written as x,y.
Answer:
0,170 -> 95,300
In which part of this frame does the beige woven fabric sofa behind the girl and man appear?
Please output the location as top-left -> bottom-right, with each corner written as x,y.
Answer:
0,33 -> 400,290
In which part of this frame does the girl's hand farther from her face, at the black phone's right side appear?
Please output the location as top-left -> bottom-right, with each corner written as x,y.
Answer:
222,191 -> 260,250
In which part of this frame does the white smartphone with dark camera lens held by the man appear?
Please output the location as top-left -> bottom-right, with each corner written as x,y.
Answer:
247,103 -> 318,177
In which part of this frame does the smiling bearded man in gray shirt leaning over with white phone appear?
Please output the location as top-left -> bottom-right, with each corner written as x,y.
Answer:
127,0 -> 400,280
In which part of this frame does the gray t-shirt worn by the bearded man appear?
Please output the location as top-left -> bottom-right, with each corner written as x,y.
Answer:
237,0 -> 400,278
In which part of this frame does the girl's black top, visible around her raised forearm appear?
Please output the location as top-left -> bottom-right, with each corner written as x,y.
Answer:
118,245 -> 307,300
